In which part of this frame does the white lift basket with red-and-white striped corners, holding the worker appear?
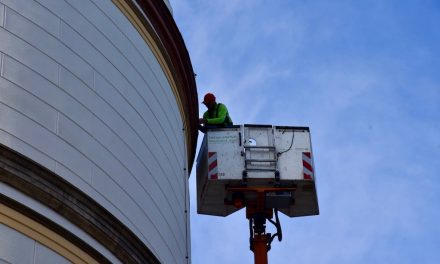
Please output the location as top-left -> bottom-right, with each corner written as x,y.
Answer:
197,125 -> 319,217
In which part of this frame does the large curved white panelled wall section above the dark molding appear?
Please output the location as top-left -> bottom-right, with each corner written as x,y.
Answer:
0,0 -> 188,263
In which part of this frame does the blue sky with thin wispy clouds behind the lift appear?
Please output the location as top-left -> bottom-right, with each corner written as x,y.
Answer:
170,0 -> 440,264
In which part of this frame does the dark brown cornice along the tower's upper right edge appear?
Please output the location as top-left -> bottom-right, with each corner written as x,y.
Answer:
118,0 -> 199,169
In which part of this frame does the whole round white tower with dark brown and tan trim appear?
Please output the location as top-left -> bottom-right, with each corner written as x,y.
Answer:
0,0 -> 198,264
